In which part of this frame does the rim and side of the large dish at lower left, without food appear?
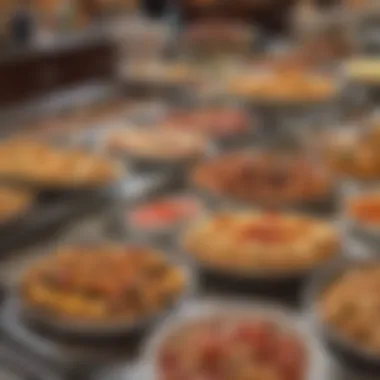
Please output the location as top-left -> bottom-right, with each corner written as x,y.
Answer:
16,242 -> 195,339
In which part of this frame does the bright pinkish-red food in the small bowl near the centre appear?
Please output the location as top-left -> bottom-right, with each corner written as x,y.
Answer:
128,196 -> 201,231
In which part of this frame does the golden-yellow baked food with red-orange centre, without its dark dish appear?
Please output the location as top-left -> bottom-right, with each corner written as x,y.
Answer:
183,212 -> 339,275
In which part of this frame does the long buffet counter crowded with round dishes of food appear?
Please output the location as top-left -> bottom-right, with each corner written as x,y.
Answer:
0,4 -> 380,380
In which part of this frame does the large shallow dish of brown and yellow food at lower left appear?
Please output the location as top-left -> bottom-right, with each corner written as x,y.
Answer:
17,243 -> 193,338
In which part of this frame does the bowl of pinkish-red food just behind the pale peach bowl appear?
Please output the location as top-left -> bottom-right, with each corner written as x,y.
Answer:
163,105 -> 257,148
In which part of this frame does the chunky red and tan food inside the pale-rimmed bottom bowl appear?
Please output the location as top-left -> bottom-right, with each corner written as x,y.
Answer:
157,310 -> 308,380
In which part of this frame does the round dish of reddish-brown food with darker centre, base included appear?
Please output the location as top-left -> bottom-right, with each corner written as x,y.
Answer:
189,149 -> 337,213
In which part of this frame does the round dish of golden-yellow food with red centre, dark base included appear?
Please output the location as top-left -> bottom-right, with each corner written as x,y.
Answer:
179,210 -> 341,298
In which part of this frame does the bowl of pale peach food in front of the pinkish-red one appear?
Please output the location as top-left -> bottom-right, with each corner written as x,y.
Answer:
102,128 -> 208,170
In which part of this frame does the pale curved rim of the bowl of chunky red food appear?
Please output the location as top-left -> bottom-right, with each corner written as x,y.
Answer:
139,298 -> 327,380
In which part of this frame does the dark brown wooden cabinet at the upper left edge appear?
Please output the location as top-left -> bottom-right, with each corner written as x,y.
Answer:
0,30 -> 116,108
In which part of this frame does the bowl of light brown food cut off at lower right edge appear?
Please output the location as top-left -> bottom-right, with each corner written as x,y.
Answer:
306,259 -> 380,376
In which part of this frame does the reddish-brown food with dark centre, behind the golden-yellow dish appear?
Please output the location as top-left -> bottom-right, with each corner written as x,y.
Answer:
192,151 -> 333,206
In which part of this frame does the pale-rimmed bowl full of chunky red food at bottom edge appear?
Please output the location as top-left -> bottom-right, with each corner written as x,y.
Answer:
143,299 -> 326,380
